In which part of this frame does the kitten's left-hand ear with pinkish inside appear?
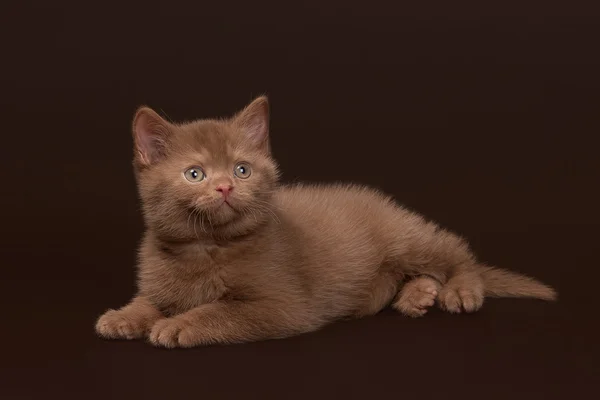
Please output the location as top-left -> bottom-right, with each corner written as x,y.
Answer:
133,107 -> 173,166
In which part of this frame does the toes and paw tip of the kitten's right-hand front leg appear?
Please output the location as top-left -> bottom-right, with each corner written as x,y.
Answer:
149,316 -> 199,349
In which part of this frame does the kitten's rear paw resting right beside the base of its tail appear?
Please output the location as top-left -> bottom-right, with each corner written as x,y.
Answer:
438,265 -> 485,313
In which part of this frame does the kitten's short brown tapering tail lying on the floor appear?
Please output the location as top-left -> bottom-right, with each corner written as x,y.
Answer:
480,266 -> 558,301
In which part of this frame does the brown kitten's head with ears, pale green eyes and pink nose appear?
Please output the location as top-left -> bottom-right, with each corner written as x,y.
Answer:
133,97 -> 278,239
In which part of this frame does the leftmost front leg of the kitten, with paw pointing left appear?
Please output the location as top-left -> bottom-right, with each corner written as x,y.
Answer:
96,296 -> 164,339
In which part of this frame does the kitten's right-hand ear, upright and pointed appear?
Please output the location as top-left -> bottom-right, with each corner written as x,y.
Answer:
234,96 -> 269,152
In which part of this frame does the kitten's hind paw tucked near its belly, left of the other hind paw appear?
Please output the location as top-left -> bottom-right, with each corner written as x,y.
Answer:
392,276 -> 442,317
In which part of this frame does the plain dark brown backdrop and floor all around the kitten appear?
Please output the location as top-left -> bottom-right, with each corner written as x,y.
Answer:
0,0 -> 600,399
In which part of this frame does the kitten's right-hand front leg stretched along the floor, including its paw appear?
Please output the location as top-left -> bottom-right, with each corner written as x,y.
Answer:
149,301 -> 320,348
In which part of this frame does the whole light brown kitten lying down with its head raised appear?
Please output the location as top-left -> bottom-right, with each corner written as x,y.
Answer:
96,97 -> 556,348
